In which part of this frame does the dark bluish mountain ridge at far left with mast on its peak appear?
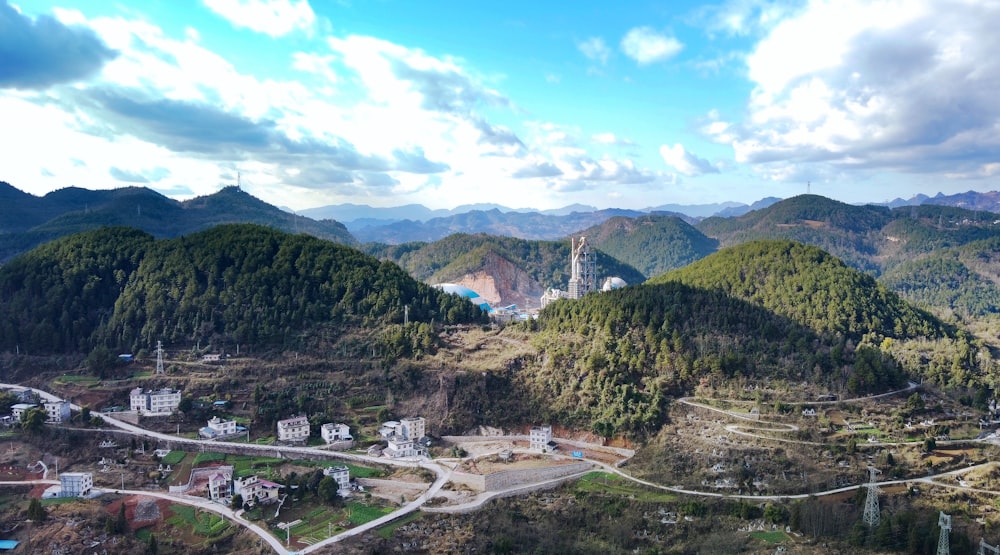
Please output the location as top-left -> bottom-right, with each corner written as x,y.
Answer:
0,183 -> 357,262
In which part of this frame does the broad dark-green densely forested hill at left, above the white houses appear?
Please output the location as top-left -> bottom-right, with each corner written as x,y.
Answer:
0,224 -> 484,352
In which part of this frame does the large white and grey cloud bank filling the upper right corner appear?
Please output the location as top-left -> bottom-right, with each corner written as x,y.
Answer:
701,0 -> 1000,179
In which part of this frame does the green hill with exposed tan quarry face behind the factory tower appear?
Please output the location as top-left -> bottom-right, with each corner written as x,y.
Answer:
365,233 -> 645,308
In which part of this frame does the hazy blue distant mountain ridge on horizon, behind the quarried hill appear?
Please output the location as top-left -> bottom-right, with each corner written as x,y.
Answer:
354,209 -> 642,244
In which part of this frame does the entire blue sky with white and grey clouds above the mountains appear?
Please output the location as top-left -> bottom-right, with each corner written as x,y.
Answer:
0,0 -> 1000,209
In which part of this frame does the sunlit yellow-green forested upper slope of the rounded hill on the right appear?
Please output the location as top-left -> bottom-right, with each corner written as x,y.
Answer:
652,240 -> 946,339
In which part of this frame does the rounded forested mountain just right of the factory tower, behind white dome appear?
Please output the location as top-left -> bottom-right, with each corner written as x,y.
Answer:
577,215 -> 719,283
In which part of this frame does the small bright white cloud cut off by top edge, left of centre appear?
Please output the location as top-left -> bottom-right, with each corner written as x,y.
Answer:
204,0 -> 316,37
